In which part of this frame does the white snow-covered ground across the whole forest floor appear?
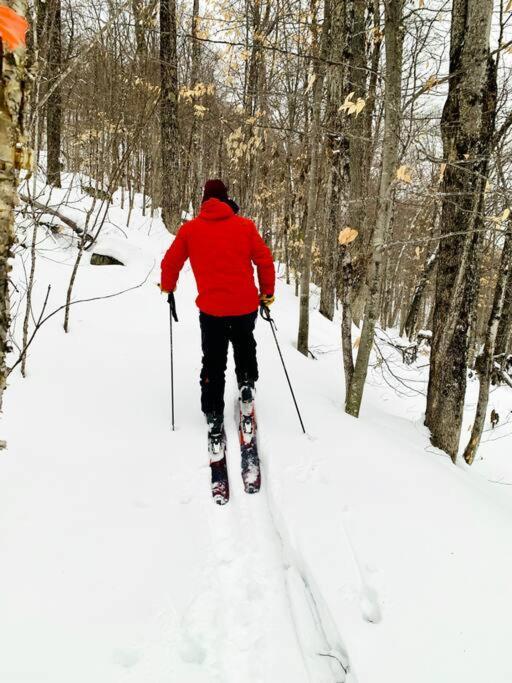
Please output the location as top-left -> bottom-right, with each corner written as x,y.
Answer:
0,178 -> 512,683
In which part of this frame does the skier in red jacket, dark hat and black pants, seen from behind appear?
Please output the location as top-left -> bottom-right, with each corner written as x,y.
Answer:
161,179 -> 275,437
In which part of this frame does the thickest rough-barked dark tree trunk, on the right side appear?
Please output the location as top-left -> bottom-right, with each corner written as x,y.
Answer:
425,0 -> 496,461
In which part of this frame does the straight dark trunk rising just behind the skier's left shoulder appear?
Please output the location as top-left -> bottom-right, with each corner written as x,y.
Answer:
160,0 -> 181,234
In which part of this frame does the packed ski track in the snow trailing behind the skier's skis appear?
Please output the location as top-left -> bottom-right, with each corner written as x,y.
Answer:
174,384 -> 350,683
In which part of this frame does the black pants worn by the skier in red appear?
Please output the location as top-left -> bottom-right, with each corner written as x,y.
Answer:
199,311 -> 258,413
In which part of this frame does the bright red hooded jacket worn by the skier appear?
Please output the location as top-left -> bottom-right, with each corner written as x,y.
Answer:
162,199 -> 276,316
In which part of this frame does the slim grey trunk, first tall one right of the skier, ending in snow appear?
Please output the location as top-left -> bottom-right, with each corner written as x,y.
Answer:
297,0 -> 330,356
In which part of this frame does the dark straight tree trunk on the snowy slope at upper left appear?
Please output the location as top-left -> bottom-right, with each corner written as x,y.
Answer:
46,0 -> 62,187
